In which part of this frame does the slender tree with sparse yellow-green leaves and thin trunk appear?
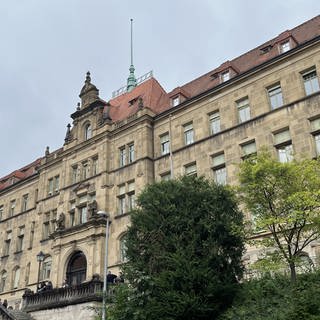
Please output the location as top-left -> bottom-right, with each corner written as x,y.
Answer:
240,151 -> 320,283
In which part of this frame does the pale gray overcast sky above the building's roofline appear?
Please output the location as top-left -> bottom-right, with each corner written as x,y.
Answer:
0,0 -> 320,177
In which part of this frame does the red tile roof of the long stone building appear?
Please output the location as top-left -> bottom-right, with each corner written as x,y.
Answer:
0,15 -> 320,190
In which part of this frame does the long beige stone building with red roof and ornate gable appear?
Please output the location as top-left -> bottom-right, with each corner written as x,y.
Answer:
0,16 -> 320,319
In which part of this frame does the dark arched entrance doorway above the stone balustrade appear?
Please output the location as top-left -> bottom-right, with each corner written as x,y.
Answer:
67,251 -> 87,286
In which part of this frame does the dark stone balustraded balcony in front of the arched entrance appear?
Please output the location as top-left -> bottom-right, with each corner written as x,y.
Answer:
22,279 -> 103,312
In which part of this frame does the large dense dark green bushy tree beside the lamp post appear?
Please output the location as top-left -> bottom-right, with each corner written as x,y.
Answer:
109,176 -> 244,320
